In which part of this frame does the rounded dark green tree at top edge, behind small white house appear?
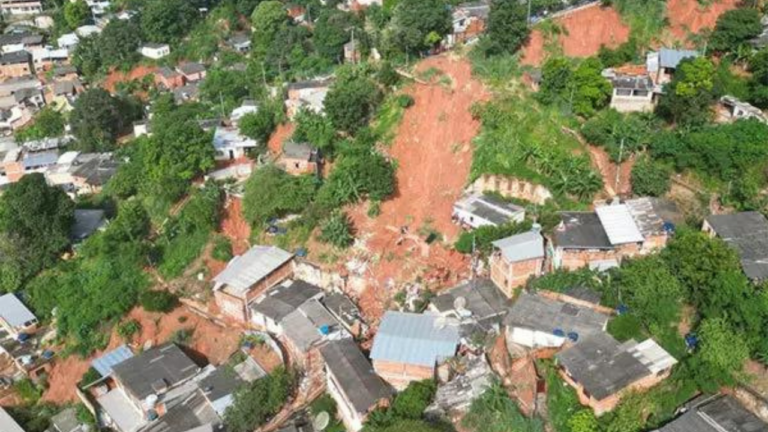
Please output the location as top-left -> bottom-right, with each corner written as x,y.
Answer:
141,0 -> 198,43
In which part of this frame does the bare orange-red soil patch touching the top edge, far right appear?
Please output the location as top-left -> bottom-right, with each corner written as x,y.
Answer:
667,0 -> 740,40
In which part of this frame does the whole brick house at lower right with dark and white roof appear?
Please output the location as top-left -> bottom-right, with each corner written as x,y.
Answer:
555,332 -> 677,415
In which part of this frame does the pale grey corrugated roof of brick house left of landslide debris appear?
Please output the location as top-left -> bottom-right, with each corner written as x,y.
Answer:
213,246 -> 293,295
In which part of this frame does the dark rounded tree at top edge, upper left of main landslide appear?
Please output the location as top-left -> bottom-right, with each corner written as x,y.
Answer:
390,0 -> 451,54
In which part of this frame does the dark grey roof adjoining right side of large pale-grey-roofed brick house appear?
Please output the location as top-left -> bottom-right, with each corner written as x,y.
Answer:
251,279 -> 323,322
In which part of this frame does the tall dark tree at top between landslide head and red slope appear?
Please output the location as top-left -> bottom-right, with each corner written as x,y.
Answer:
486,0 -> 530,54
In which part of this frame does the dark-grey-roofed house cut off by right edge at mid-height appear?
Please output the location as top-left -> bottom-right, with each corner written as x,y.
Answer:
701,211 -> 768,282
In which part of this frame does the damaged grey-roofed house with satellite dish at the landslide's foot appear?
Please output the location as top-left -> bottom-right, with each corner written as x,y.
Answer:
428,279 -> 508,339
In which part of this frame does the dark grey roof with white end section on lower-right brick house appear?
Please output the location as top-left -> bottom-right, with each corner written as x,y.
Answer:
556,332 -> 677,401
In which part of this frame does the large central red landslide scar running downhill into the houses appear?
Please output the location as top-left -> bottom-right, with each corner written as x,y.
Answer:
350,56 -> 488,321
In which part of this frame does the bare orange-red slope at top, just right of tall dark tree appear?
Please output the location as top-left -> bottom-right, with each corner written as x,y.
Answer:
521,0 -> 632,66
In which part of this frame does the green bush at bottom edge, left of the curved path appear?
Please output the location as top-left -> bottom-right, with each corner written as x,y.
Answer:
224,367 -> 295,432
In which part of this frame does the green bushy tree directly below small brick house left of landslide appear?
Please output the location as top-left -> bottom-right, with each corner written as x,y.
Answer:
243,165 -> 320,225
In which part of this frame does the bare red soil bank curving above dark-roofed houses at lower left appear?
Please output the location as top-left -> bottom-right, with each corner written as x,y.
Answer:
43,307 -> 240,404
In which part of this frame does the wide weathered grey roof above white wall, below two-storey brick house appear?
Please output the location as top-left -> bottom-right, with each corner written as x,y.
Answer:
505,291 -> 609,340
